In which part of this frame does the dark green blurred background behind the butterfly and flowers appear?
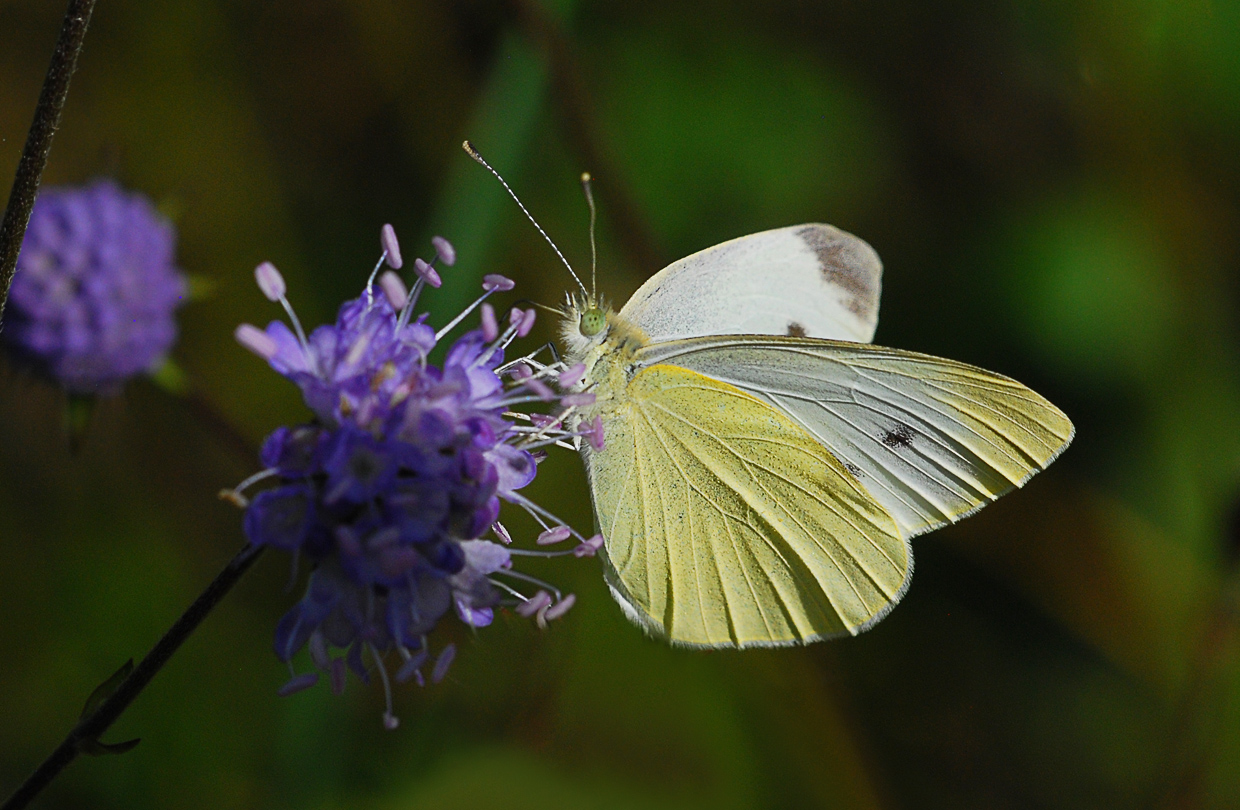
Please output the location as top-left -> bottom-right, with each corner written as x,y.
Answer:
0,0 -> 1240,810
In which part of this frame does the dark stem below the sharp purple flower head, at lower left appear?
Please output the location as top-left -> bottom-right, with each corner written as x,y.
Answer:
0,545 -> 263,810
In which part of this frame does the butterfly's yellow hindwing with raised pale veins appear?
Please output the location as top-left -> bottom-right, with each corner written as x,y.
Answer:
587,365 -> 911,646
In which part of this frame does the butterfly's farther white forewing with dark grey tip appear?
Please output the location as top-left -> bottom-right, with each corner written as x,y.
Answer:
620,223 -> 883,342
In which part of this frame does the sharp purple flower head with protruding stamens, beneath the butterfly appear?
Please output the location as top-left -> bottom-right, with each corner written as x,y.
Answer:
229,227 -> 599,728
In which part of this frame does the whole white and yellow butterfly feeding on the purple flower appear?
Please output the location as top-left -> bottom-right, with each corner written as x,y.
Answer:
466,146 -> 1074,648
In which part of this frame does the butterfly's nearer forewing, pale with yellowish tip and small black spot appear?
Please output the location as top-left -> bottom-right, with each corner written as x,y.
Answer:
636,337 -> 1074,538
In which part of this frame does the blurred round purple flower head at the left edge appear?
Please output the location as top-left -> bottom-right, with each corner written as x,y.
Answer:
4,180 -> 186,393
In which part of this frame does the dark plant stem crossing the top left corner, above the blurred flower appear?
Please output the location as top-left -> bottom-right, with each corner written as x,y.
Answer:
0,0 -> 94,316
